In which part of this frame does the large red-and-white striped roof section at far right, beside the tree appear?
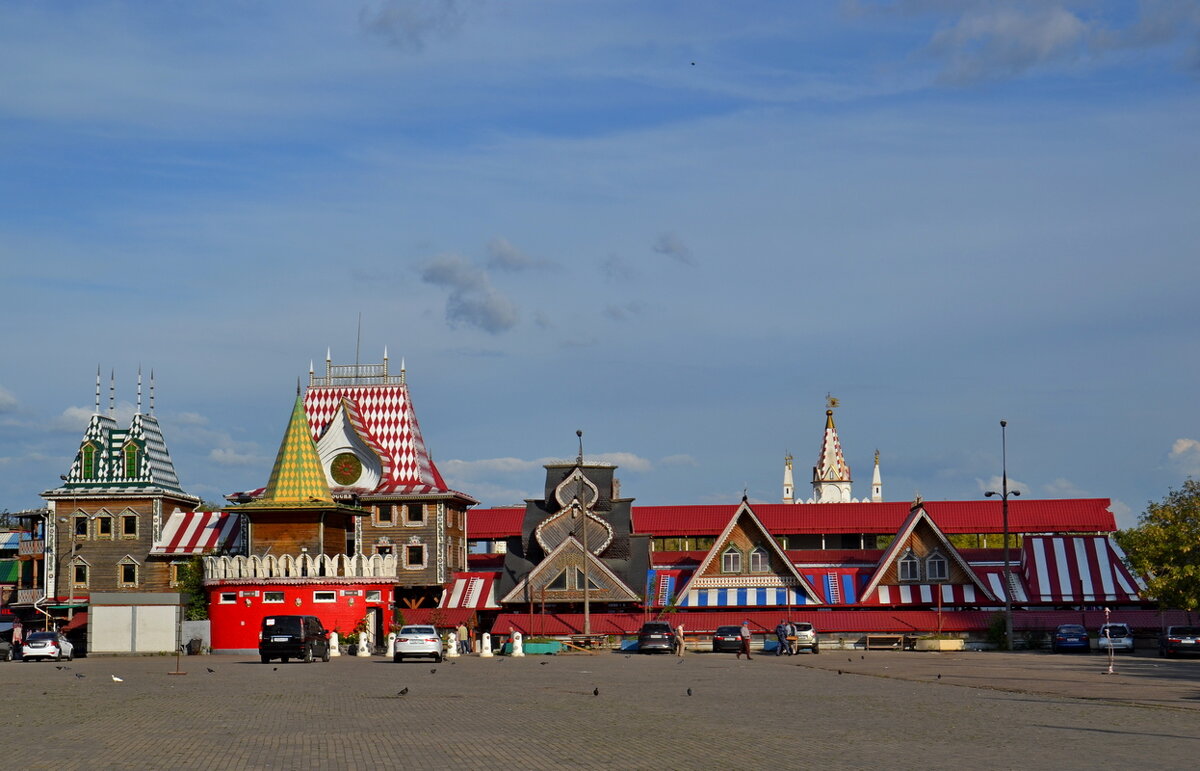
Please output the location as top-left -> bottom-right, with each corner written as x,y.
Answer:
1021,536 -> 1141,603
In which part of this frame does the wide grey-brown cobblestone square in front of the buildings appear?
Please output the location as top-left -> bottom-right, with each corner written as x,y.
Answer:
0,651 -> 1200,771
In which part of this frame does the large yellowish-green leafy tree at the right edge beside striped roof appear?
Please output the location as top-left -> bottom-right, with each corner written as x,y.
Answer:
1117,479 -> 1200,610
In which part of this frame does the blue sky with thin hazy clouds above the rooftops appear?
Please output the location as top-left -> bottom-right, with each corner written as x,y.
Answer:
0,0 -> 1200,527
